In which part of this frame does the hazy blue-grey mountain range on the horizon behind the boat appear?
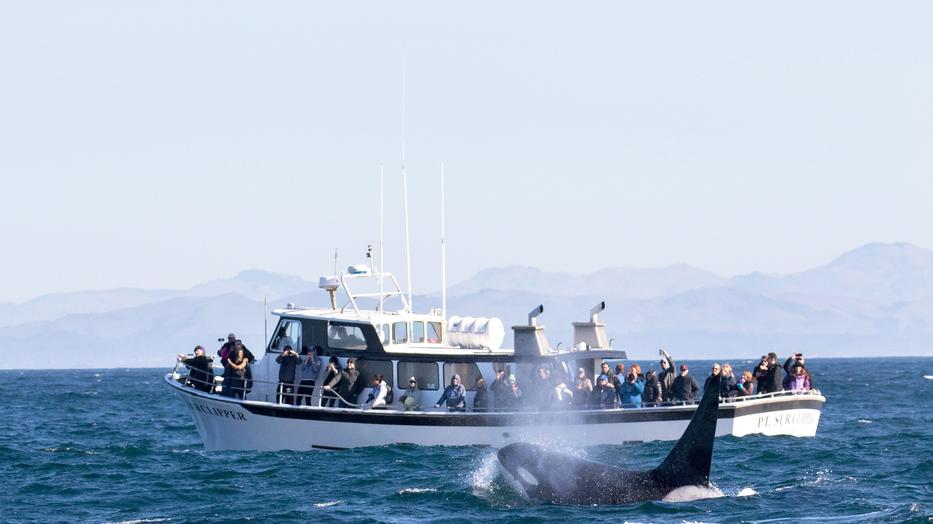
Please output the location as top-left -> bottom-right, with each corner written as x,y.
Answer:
0,243 -> 933,368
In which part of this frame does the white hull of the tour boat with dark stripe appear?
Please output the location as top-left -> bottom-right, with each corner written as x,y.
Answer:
166,374 -> 825,450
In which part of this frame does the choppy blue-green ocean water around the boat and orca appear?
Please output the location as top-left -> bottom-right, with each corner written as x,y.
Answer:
0,358 -> 933,523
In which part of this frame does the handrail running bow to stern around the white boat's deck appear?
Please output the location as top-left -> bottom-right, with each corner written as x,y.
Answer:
172,362 -> 822,413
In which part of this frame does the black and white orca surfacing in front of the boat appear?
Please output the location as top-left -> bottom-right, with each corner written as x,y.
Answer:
498,378 -> 719,505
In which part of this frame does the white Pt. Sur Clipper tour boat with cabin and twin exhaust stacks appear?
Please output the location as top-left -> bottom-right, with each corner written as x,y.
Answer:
165,265 -> 825,450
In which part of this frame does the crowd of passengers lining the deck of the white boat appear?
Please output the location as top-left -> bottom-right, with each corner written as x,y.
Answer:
178,333 -> 813,412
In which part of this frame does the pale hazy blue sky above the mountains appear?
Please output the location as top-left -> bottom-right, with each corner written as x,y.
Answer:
0,1 -> 933,301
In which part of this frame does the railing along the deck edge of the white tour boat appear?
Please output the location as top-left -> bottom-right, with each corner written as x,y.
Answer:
172,361 -> 821,412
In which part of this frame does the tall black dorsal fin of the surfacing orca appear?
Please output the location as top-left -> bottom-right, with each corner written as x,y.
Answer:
652,376 -> 721,487
